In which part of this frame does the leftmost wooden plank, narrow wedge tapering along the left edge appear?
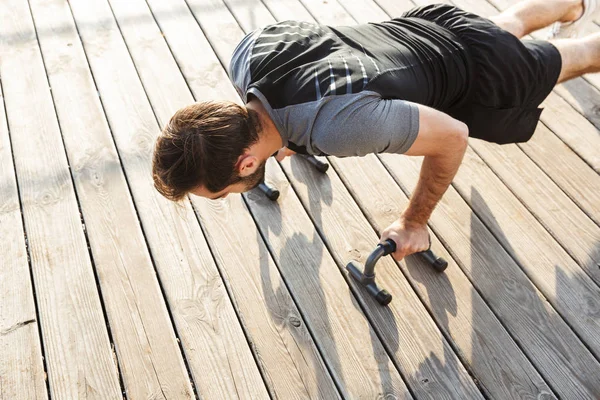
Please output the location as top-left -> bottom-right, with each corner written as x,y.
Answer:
0,73 -> 48,400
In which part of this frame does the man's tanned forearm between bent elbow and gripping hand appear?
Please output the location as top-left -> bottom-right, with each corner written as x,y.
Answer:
400,140 -> 466,226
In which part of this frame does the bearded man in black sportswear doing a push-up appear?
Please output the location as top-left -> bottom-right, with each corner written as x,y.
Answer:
153,0 -> 600,260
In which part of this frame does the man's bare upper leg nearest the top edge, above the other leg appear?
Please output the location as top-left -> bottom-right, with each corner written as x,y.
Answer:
490,0 -> 583,38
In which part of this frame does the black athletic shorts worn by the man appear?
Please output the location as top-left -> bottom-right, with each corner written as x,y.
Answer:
403,4 -> 562,143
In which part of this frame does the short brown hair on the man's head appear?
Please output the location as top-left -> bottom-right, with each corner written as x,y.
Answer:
152,101 -> 260,201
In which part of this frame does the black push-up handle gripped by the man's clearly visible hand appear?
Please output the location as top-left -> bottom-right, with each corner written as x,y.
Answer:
346,239 -> 448,306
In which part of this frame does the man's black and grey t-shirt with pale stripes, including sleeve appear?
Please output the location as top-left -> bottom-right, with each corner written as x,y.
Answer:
230,18 -> 469,156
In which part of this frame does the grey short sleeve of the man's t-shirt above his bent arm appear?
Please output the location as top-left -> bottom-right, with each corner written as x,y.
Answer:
302,92 -> 419,157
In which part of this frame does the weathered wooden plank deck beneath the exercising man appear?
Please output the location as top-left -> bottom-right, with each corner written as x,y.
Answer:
0,0 -> 600,400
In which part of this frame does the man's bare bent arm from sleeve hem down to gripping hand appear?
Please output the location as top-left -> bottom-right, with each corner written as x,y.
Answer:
381,105 -> 469,260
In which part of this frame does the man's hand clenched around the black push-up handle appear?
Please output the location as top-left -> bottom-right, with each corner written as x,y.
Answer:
381,217 -> 429,261
